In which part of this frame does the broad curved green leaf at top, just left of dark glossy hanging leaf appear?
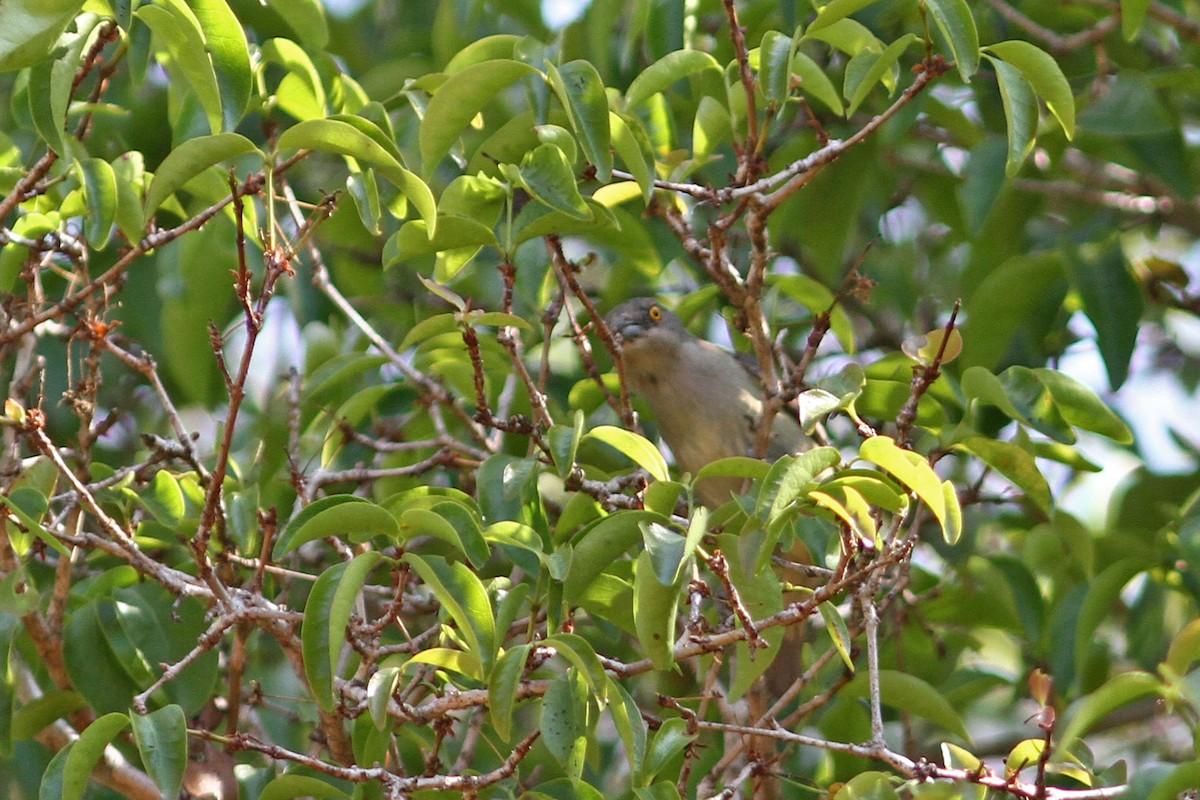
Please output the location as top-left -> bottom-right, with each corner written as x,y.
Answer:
418,59 -> 536,176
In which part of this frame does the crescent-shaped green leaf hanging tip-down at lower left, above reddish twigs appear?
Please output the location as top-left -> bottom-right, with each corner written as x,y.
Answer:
300,551 -> 383,711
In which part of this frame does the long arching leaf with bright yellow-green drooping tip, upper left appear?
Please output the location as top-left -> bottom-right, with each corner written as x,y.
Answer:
278,118 -> 438,236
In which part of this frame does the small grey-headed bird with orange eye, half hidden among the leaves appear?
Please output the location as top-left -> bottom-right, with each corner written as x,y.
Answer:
605,297 -> 811,507
